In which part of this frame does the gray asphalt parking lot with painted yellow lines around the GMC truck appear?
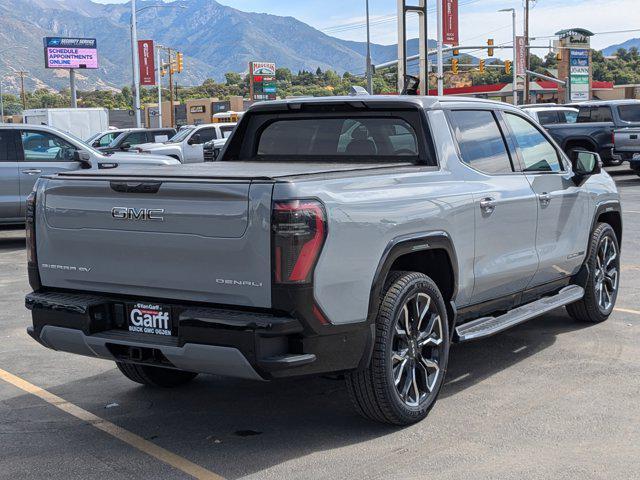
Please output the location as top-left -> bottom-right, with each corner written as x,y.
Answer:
0,167 -> 640,480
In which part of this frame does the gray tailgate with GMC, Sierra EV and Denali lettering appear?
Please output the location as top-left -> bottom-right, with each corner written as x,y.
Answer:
36,176 -> 273,308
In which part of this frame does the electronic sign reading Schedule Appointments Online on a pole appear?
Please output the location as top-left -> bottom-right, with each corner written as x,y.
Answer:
44,37 -> 98,69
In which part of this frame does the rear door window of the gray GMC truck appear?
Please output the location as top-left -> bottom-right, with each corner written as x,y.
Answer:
450,110 -> 514,174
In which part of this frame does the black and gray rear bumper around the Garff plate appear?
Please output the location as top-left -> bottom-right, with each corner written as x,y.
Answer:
25,291 -> 372,380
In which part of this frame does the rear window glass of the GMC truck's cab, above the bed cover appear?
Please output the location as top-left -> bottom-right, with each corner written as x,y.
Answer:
256,117 -> 419,158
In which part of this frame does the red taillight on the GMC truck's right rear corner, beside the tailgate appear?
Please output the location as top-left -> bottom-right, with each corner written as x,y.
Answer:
271,200 -> 327,284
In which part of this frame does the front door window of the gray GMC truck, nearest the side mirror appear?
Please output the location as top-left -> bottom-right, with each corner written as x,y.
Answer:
504,113 -> 563,172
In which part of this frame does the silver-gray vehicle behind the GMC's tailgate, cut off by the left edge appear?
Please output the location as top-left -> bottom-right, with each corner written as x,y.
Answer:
0,124 -> 179,224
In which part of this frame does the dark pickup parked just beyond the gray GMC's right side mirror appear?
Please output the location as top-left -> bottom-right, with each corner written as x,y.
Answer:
545,100 -> 640,168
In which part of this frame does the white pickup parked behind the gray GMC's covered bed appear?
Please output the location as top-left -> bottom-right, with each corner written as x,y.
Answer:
135,123 -> 236,163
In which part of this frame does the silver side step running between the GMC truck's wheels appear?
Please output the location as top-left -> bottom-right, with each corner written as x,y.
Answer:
456,285 -> 584,342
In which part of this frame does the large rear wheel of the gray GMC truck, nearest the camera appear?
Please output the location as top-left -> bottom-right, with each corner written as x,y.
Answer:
345,272 -> 450,425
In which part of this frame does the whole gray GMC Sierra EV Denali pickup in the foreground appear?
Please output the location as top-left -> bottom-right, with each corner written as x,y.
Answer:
26,97 -> 622,425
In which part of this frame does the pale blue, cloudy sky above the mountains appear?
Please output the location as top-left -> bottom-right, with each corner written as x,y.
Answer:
94,0 -> 640,55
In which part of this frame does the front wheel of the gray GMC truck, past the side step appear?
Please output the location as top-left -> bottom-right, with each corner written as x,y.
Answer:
567,223 -> 620,323
